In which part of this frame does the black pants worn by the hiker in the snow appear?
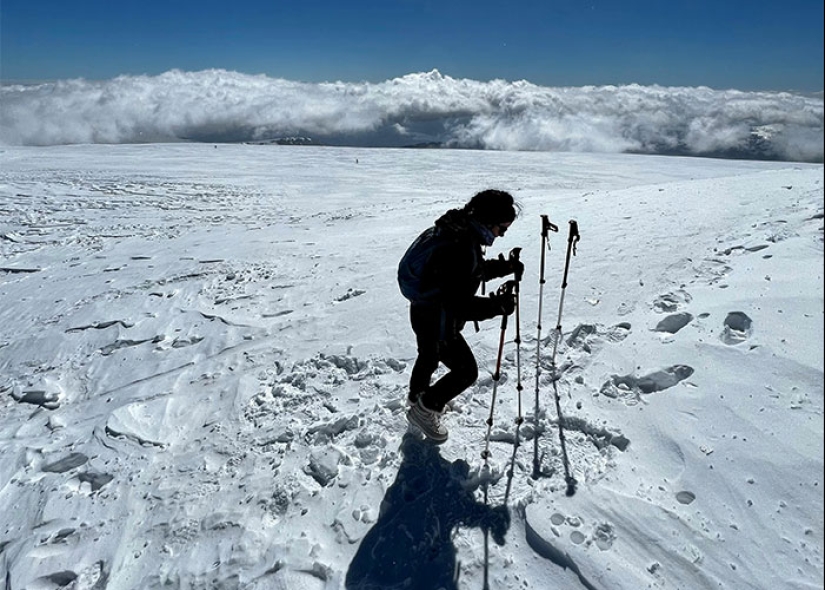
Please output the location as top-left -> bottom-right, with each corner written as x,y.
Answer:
410,305 -> 478,412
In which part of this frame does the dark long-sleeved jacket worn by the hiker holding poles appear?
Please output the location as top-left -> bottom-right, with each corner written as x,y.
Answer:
404,209 -> 512,338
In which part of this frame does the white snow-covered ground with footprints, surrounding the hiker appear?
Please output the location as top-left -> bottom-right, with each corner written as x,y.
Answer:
0,144 -> 823,590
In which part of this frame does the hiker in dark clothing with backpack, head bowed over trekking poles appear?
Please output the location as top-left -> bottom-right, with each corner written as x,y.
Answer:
398,189 -> 524,443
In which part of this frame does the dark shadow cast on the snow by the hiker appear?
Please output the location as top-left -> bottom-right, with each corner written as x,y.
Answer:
346,433 -> 510,590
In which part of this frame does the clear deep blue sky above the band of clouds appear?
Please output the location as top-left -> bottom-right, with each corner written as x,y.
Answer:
0,0 -> 823,92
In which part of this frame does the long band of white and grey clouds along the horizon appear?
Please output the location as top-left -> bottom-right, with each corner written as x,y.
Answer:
0,70 -> 823,162
